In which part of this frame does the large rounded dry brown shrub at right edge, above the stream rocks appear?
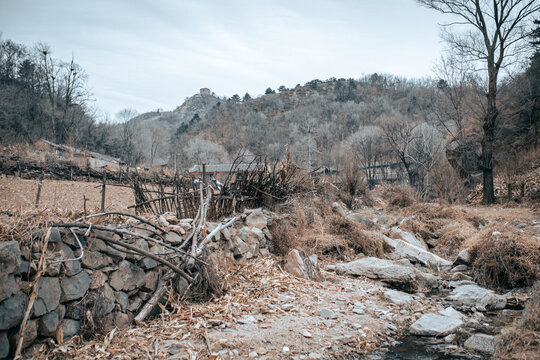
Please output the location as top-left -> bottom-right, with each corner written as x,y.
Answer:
471,225 -> 540,288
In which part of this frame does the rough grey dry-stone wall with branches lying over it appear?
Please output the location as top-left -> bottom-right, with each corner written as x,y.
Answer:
0,209 -> 271,358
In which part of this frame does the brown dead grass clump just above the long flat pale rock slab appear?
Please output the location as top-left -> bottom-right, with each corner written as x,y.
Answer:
328,215 -> 384,257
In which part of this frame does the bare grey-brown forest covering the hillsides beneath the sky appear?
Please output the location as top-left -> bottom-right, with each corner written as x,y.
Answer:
0,16 -> 540,200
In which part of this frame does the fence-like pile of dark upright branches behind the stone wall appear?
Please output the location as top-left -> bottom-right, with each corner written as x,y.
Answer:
132,156 -> 311,219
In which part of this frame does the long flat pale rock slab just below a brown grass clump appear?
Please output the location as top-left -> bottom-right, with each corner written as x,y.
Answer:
327,257 -> 440,291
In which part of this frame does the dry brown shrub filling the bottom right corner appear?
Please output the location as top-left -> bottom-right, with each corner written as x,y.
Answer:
493,282 -> 540,360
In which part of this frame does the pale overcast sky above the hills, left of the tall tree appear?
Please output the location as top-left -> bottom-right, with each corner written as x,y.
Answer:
0,0 -> 445,118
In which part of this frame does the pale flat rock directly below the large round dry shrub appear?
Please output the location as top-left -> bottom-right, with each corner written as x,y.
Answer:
447,285 -> 506,310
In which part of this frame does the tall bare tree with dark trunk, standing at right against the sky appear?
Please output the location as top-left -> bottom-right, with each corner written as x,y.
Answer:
417,0 -> 540,204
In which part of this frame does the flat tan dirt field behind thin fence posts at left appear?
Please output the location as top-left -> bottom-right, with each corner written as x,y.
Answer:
0,177 -> 134,212
